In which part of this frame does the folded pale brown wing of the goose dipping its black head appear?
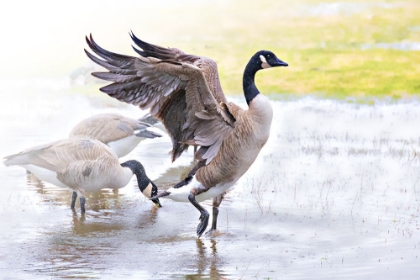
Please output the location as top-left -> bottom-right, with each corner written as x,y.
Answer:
5,138 -> 118,172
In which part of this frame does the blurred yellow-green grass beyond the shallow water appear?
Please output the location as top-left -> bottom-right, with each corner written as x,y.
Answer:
146,0 -> 420,98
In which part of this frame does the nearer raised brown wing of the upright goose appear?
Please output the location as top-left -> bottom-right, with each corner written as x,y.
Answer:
85,33 -> 235,164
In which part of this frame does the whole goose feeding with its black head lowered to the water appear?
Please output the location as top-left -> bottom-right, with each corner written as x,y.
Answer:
4,138 -> 161,213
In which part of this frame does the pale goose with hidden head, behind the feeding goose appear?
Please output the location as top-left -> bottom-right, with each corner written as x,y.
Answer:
69,113 -> 162,157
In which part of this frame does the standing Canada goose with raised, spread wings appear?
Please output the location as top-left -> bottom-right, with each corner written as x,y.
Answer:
85,33 -> 288,237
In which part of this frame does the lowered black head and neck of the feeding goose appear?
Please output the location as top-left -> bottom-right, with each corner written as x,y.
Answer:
121,160 -> 162,207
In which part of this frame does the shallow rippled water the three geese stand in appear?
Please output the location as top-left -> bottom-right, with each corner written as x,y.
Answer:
0,81 -> 420,279
